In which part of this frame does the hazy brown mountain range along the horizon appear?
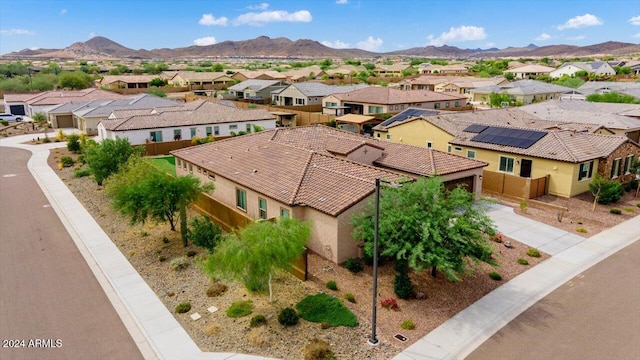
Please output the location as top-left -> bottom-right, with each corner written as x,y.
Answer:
2,36 -> 640,60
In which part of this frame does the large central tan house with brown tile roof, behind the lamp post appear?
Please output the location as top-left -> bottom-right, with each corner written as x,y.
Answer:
172,125 -> 487,263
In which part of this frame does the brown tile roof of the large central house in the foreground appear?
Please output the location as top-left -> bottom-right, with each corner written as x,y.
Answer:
172,126 -> 486,216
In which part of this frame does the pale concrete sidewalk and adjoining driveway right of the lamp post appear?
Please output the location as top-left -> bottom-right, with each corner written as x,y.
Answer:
394,206 -> 640,360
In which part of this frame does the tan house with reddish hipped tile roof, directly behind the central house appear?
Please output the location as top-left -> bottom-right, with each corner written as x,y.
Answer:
322,86 -> 467,116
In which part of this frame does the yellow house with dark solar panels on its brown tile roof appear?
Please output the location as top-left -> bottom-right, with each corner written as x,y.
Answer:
374,108 -> 640,197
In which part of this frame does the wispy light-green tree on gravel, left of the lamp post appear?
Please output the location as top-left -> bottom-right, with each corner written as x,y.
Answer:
205,217 -> 311,302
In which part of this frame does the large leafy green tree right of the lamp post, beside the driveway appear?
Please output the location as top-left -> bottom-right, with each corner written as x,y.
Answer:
351,177 -> 496,281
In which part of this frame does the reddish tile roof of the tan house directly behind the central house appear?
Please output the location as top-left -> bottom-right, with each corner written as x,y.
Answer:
333,86 -> 467,105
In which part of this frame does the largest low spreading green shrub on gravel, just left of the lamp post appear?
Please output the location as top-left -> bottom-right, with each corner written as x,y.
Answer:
296,293 -> 358,327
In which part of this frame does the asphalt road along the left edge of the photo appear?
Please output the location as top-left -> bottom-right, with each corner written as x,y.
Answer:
0,148 -> 142,360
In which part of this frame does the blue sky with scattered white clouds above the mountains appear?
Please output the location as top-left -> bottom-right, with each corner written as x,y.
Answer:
0,0 -> 640,54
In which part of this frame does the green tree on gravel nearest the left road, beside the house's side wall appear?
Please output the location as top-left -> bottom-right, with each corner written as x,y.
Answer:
107,156 -> 213,243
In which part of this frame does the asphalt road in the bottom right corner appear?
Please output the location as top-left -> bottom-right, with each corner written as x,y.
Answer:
467,241 -> 640,360
